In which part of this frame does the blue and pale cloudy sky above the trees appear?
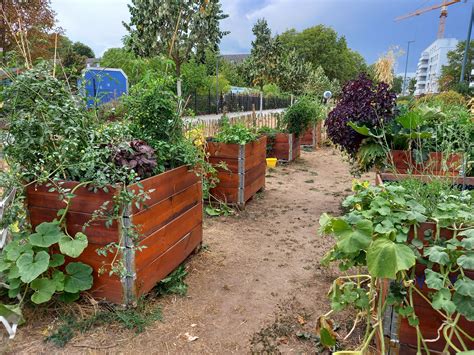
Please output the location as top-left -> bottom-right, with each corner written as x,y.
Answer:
52,0 -> 474,73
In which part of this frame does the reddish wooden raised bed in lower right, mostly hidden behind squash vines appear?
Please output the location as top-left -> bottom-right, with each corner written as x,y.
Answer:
383,222 -> 474,355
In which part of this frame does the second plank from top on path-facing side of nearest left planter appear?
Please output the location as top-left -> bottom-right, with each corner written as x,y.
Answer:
132,182 -> 202,238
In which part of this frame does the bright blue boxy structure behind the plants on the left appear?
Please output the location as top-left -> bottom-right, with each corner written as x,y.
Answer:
78,68 -> 128,107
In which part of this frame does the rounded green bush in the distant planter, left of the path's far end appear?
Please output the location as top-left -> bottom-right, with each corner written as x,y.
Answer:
283,97 -> 322,136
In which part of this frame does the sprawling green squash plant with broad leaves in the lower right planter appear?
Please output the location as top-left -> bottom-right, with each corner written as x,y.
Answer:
320,182 -> 474,353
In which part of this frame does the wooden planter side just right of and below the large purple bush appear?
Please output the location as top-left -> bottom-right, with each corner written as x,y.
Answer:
388,150 -> 462,176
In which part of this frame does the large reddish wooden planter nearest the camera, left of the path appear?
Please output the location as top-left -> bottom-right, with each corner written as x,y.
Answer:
27,166 -> 203,305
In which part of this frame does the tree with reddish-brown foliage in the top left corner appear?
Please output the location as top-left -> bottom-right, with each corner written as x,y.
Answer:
0,0 -> 60,62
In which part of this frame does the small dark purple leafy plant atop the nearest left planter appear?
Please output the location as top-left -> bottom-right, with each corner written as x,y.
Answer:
112,139 -> 157,178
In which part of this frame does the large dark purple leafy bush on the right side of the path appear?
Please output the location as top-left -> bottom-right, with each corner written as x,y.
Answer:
325,74 -> 396,170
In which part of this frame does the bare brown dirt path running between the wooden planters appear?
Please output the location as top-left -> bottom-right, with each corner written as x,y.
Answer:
7,149 -> 372,354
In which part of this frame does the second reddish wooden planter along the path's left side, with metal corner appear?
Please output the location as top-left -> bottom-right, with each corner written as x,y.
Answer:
207,137 -> 267,207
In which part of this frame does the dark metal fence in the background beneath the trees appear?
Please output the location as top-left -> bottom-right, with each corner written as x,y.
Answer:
186,91 -> 291,115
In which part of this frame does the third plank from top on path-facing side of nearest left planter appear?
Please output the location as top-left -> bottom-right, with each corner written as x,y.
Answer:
135,203 -> 202,272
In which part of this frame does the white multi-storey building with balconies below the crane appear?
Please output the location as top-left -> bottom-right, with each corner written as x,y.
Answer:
415,38 -> 458,95
